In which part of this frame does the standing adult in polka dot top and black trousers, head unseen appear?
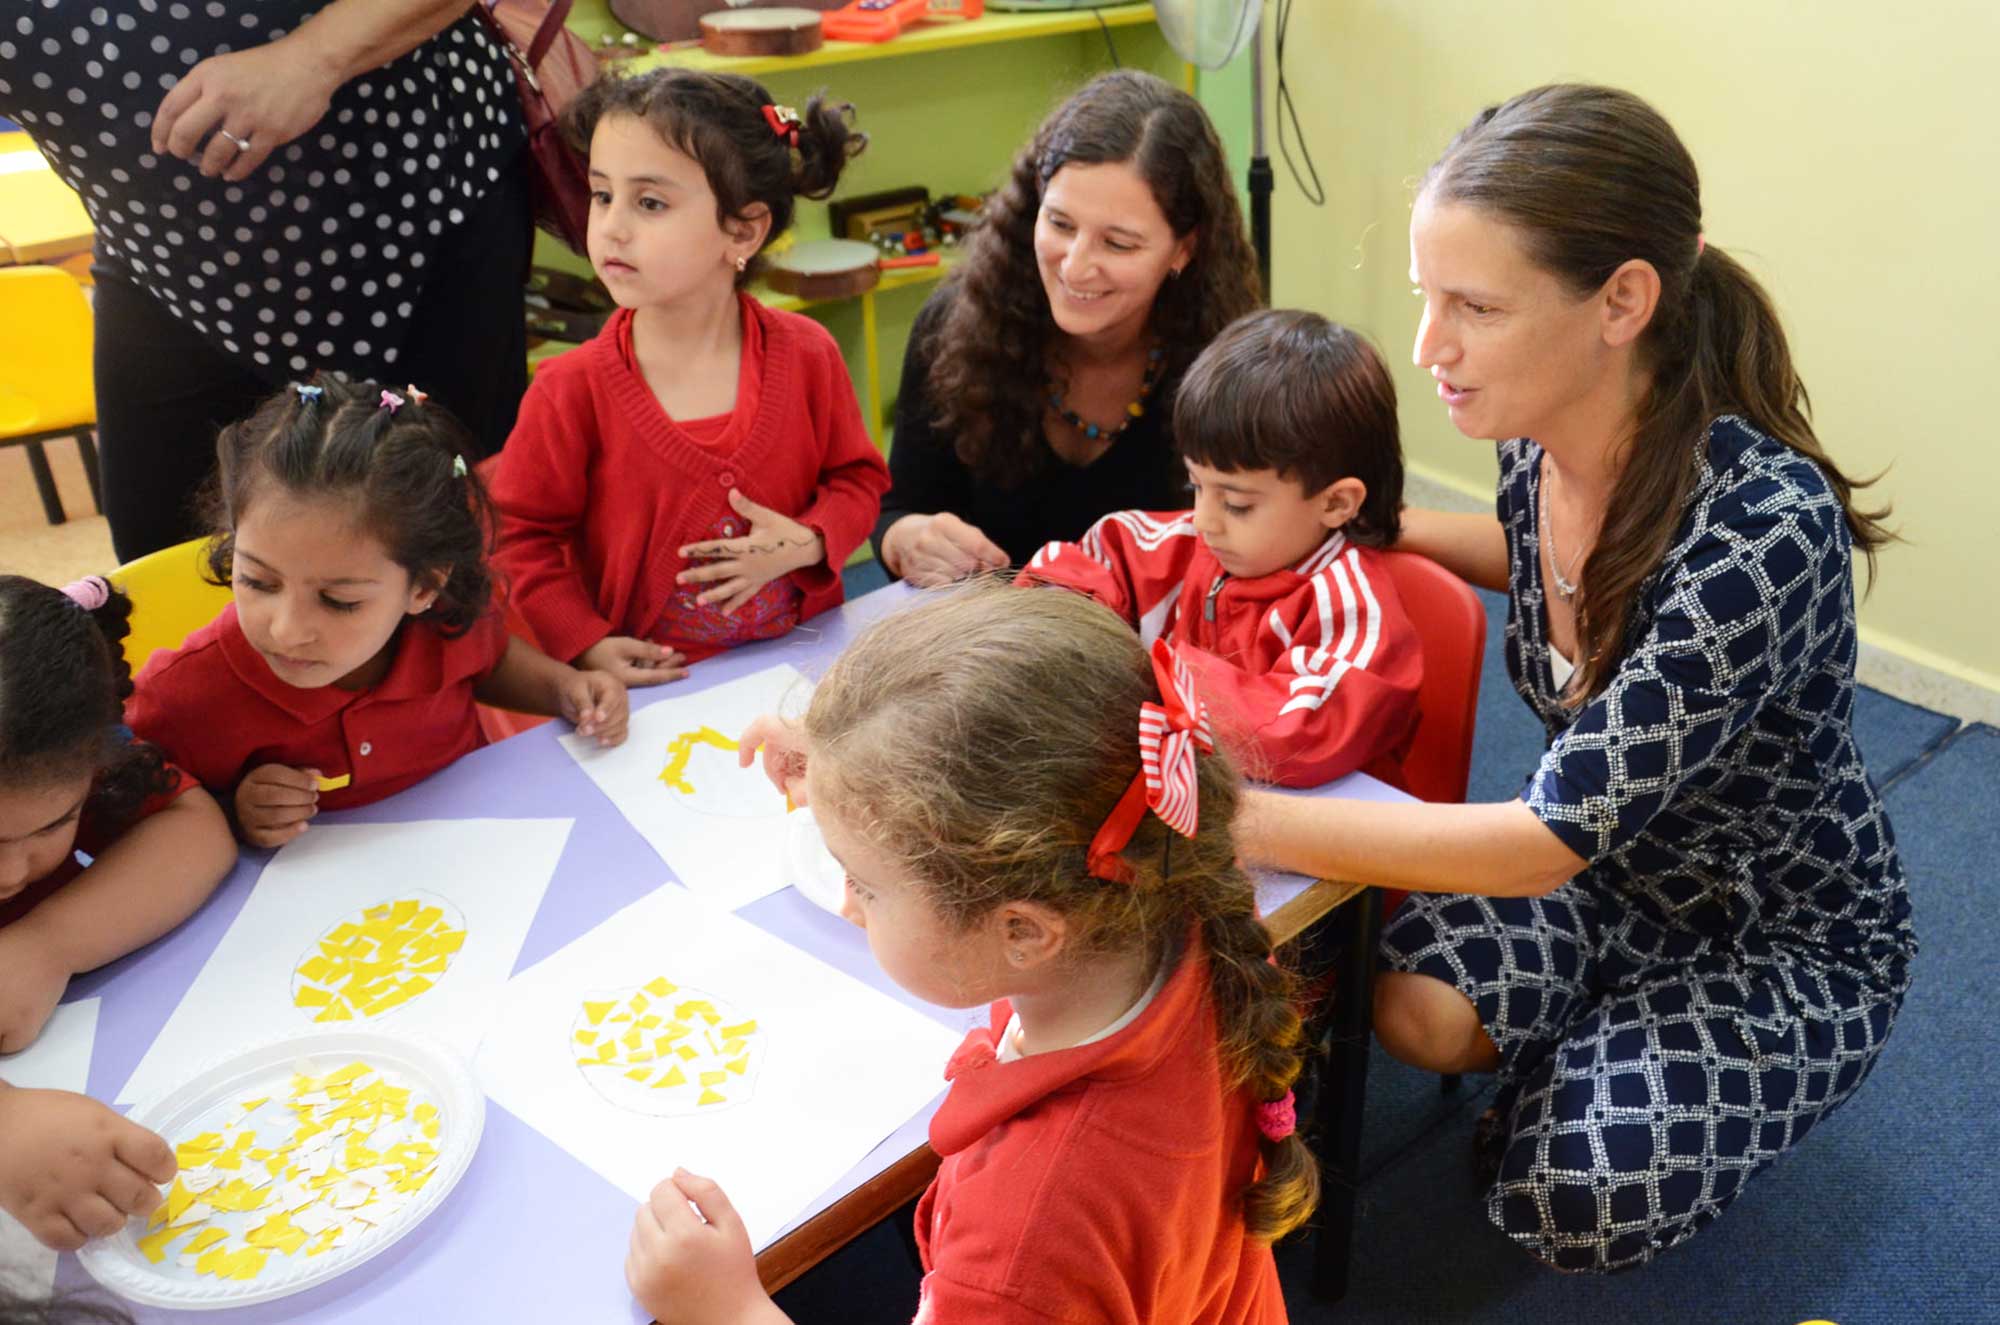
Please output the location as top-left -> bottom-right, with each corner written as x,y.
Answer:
0,0 -> 532,558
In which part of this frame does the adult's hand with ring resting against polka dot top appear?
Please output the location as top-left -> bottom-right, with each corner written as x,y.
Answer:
152,34 -> 340,180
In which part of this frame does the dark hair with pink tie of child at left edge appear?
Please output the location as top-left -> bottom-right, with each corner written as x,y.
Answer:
0,574 -> 174,833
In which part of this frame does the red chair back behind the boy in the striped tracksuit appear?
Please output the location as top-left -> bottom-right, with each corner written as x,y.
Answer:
1382,552 -> 1486,801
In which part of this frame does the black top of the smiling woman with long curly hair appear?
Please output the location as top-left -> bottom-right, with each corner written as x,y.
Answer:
874,286 -> 1188,568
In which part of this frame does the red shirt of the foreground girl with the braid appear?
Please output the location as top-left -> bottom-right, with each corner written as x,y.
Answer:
916,943 -> 1286,1325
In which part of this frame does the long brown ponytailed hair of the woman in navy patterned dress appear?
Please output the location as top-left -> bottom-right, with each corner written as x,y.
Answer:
1420,84 -> 1894,705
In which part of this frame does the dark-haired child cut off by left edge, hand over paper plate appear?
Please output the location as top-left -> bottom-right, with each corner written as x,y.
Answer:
0,574 -> 236,1256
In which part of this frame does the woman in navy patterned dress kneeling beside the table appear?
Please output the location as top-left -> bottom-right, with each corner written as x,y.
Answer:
1242,86 -> 1916,1273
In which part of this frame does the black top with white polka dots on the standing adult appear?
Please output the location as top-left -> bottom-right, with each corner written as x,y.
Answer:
0,0 -> 526,384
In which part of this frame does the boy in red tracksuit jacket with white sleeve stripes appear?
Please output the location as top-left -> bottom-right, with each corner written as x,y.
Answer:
1018,310 -> 1424,787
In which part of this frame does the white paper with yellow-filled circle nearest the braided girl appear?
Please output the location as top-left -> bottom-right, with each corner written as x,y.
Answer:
476,887 -> 960,1249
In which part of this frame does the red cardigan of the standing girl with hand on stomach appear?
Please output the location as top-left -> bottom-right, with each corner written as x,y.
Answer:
492,296 -> 888,658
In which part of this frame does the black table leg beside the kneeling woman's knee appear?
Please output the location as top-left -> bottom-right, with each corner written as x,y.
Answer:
1312,889 -> 1382,1301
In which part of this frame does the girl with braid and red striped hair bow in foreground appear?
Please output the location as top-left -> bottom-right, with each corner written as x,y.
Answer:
626,584 -> 1318,1325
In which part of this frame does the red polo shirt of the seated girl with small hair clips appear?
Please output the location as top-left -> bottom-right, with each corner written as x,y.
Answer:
126,602 -> 508,811
